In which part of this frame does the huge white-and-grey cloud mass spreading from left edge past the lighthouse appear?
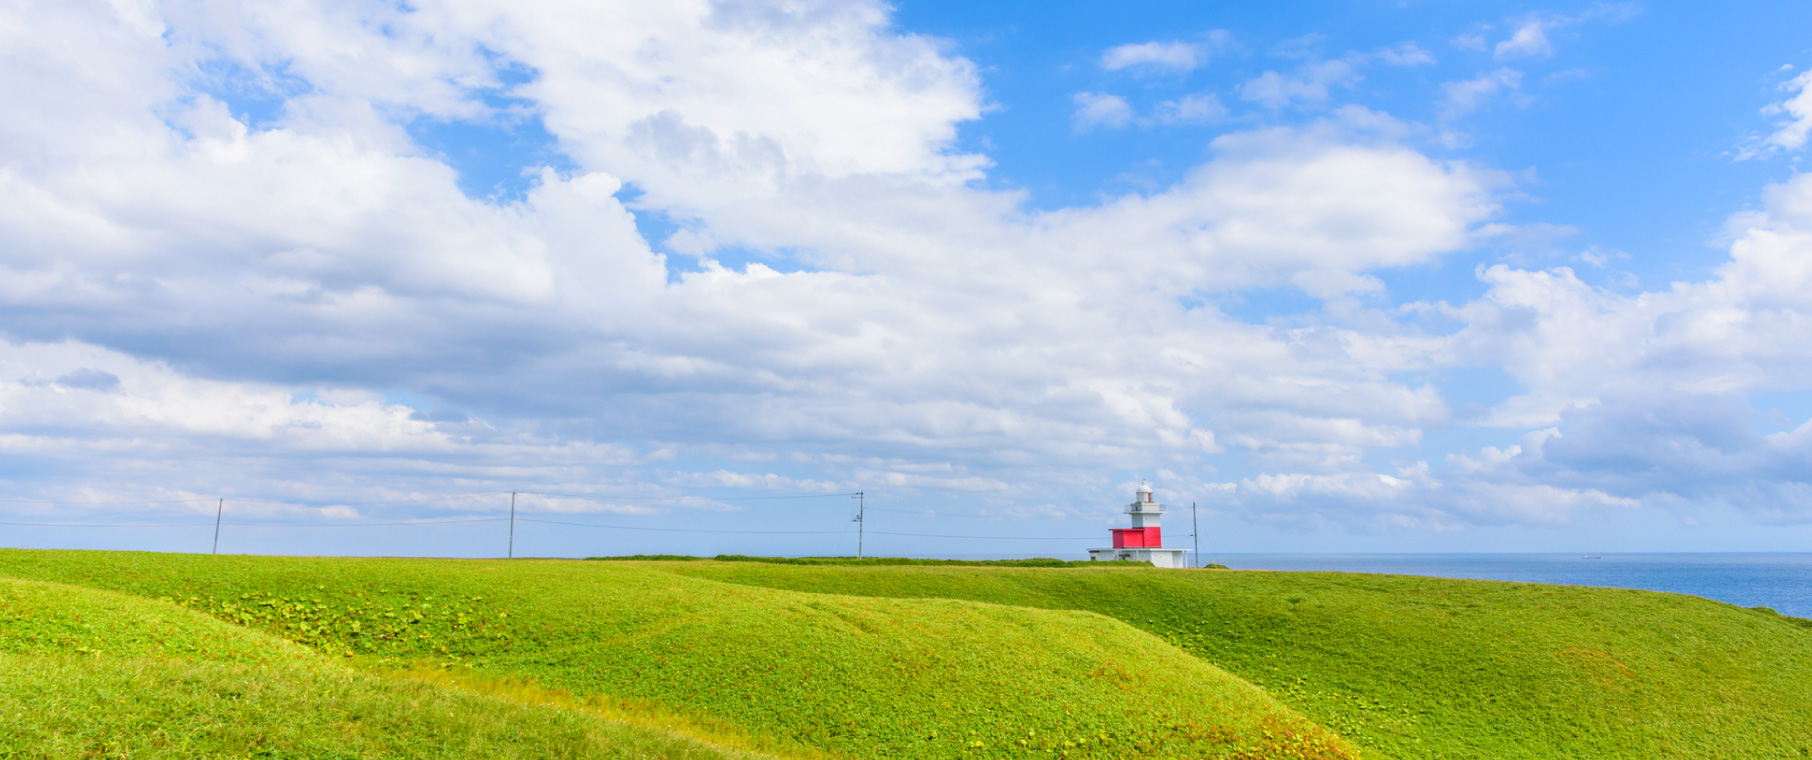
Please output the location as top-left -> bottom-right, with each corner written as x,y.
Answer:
0,5 -> 1495,529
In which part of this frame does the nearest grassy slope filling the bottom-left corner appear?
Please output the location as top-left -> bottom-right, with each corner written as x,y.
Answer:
0,579 -> 739,760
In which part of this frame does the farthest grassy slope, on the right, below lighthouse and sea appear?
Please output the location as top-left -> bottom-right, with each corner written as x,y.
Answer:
665,562 -> 1812,758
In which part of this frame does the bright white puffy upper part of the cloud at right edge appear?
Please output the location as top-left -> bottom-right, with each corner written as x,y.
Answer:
1455,176 -> 1812,404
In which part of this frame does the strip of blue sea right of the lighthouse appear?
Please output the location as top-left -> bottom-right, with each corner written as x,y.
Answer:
1203,553 -> 1812,619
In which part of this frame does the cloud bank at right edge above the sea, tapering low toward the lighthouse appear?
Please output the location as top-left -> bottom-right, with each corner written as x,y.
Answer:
1203,162 -> 1812,530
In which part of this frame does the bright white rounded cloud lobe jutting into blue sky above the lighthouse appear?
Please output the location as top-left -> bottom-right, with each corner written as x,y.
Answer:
1038,109 -> 1500,290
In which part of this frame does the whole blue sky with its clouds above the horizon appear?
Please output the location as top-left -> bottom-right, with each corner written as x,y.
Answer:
0,0 -> 1812,559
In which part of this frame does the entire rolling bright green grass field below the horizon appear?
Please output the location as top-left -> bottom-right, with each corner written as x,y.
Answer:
0,551 -> 1812,758
